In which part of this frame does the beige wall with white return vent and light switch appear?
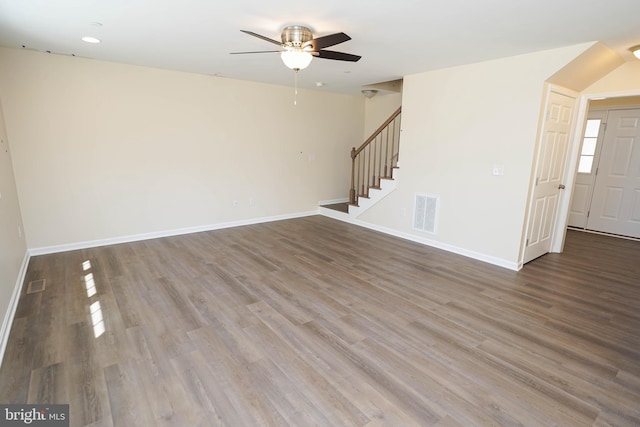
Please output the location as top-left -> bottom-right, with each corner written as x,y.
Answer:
360,45 -> 589,268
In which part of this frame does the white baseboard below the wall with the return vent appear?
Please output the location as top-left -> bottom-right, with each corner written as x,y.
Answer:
320,213 -> 522,271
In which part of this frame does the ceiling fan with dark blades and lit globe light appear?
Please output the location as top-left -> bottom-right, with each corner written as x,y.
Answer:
231,25 -> 361,71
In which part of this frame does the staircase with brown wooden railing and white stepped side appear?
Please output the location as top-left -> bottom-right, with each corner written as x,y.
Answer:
348,107 -> 402,218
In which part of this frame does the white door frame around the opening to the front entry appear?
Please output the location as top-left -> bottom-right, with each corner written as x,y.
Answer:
551,89 -> 640,253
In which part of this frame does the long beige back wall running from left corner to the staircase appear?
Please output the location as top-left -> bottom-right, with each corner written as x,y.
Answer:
0,49 -> 365,249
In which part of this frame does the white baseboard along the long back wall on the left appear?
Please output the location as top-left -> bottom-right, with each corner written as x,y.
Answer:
29,210 -> 319,256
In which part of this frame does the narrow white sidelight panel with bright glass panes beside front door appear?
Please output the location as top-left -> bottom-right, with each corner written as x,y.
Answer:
567,110 -> 607,228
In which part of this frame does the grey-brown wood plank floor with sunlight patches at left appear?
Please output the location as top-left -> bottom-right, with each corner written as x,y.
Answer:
0,216 -> 640,427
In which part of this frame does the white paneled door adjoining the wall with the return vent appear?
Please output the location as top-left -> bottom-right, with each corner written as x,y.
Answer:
523,90 -> 576,263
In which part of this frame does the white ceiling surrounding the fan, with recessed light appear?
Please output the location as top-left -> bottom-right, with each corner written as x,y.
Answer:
0,0 -> 640,94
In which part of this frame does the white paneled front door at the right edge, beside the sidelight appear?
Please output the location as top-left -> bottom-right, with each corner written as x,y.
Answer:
586,109 -> 640,238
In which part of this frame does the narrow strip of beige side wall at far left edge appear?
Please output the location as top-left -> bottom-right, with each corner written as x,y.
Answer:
0,98 -> 27,361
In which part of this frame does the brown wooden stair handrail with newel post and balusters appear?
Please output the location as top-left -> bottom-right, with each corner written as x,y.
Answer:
349,107 -> 402,205
